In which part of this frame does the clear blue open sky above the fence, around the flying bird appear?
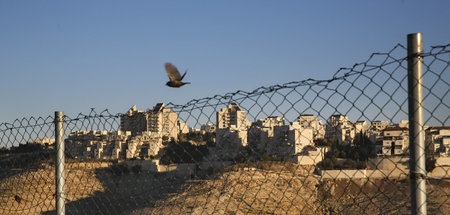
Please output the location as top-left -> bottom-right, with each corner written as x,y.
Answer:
0,0 -> 450,122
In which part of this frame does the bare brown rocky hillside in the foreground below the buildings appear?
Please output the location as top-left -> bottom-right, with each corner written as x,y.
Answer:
0,162 -> 450,214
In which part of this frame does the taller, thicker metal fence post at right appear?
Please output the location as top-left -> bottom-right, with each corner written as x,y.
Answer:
408,33 -> 427,215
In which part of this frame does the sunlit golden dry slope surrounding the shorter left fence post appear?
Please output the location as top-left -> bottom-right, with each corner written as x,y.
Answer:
0,163 -> 104,214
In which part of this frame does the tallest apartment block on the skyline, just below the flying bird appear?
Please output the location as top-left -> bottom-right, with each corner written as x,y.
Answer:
120,103 -> 179,139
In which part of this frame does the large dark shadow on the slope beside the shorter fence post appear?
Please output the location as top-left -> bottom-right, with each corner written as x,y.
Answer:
43,165 -> 199,214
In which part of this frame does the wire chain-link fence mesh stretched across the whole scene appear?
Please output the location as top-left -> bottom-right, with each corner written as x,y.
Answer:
0,34 -> 450,214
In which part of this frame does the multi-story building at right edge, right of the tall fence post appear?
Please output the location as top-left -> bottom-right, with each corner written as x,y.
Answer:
425,126 -> 450,156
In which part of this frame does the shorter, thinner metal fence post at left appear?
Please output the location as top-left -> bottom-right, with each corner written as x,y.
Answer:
55,111 -> 66,215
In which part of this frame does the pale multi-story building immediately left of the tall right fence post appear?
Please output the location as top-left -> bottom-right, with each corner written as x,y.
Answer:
381,127 -> 409,155
